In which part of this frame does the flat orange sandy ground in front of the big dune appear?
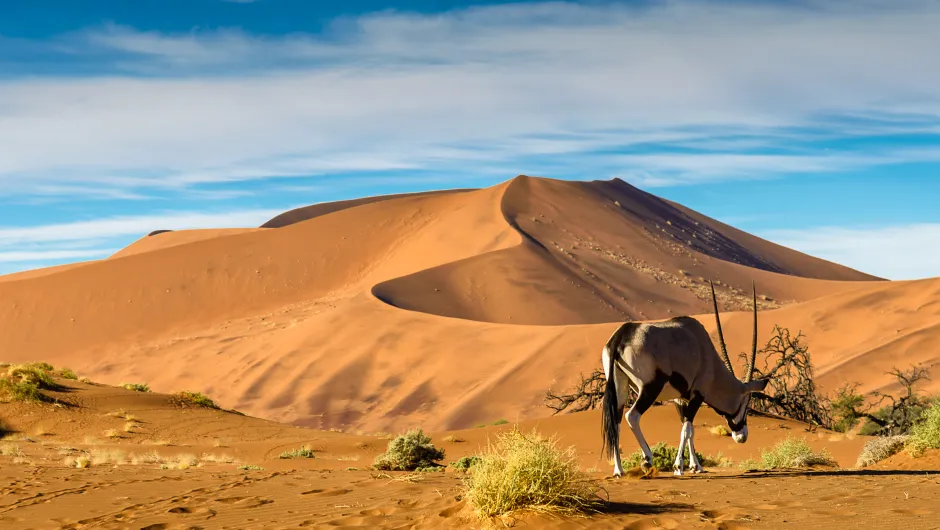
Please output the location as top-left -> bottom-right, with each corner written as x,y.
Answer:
0,380 -> 940,529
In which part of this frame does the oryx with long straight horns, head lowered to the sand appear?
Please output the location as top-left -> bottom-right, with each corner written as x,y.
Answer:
601,285 -> 768,477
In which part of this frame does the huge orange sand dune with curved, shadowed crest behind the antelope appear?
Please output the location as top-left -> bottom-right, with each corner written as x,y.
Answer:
0,176 -> 940,431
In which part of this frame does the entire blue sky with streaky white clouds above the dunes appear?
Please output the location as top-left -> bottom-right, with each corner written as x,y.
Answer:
0,0 -> 940,279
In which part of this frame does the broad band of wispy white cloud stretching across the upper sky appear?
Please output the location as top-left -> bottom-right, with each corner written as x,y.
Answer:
0,0 -> 940,194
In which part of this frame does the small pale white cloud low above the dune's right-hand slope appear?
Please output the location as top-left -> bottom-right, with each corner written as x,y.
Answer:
757,223 -> 940,280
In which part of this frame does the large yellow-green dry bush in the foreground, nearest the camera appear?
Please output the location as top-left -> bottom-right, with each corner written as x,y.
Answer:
466,428 -> 603,518
